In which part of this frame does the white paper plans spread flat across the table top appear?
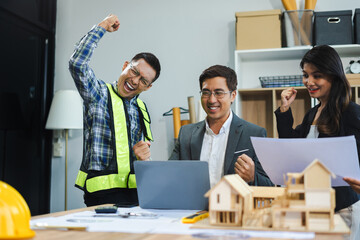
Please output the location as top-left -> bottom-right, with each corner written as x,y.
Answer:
30,207 -> 315,239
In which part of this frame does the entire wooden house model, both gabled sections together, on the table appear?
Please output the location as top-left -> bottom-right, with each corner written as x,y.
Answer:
205,160 -> 335,230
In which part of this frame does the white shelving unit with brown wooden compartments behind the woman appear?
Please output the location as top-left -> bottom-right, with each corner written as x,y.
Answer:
234,44 -> 360,137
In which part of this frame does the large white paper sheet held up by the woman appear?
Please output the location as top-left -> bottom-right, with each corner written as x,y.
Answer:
251,136 -> 360,186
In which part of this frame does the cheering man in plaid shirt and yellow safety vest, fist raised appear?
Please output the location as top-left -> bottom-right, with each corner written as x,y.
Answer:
69,14 -> 161,206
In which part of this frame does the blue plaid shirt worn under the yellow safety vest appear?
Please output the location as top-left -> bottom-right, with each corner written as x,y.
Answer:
69,26 -> 142,171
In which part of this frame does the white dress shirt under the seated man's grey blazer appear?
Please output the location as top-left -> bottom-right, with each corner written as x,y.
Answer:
200,111 -> 233,187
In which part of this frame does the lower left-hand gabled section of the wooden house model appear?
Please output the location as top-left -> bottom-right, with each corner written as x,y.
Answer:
205,174 -> 285,227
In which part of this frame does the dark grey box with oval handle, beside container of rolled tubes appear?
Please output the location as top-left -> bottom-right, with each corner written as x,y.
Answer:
313,10 -> 353,45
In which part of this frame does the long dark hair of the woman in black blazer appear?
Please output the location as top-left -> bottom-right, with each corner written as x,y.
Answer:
300,45 -> 351,135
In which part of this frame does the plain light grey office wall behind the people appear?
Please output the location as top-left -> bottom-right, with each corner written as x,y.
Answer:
51,0 -> 360,212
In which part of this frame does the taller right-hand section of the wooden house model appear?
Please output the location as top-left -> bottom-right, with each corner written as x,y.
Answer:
272,160 -> 335,230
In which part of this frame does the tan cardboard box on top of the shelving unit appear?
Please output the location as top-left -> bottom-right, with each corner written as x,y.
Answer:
235,9 -> 281,50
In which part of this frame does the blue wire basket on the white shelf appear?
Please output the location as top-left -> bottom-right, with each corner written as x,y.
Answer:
259,75 -> 303,88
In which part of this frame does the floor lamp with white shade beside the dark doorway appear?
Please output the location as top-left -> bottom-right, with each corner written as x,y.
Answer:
45,90 -> 83,210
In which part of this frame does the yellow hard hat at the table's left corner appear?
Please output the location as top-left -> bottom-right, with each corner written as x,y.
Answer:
0,181 -> 35,239
